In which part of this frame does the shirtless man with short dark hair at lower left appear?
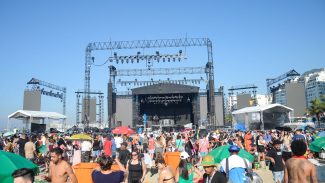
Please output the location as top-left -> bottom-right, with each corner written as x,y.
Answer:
44,147 -> 78,183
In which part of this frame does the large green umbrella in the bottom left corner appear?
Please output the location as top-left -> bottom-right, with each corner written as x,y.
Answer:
0,151 -> 39,183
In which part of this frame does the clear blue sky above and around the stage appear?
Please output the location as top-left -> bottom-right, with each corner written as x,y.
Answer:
0,0 -> 325,129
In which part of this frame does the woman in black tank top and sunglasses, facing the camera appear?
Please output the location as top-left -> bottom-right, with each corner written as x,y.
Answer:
126,151 -> 147,183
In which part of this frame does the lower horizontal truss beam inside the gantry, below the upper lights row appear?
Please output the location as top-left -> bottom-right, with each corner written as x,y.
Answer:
116,67 -> 206,76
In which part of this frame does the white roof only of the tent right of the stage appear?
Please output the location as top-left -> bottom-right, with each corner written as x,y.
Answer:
232,104 -> 293,114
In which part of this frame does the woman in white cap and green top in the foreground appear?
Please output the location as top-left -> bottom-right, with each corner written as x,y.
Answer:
175,152 -> 202,183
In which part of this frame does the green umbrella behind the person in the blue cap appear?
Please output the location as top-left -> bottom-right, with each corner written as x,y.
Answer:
208,145 -> 254,163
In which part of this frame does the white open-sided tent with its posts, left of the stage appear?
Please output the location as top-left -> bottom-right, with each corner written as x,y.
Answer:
7,110 -> 67,129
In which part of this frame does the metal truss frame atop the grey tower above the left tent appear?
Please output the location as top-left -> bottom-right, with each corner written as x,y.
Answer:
27,78 -> 67,115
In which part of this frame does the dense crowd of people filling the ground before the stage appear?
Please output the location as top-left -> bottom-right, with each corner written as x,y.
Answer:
0,127 -> 317,183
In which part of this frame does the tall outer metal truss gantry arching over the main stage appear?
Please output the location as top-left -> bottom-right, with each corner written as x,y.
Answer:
84,38 -> 215,125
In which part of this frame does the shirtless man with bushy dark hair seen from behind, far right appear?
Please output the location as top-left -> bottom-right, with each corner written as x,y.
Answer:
284,140 -> 318,183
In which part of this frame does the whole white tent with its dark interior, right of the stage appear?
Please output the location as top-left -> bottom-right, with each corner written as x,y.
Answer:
232,104 -> 293,130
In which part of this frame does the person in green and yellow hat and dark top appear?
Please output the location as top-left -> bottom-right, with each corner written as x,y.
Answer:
201,155 -> 227,183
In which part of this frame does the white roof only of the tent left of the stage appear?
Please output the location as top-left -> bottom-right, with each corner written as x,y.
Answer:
8,110 -> 67,119
